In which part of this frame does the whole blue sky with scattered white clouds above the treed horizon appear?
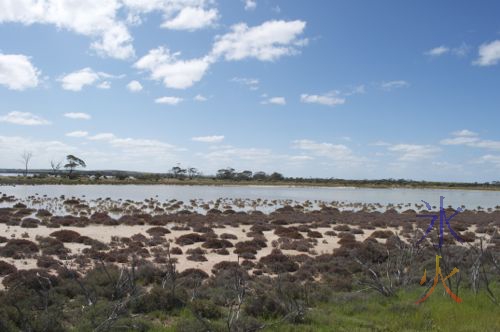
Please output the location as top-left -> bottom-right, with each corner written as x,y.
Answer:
0,0 -> 500,181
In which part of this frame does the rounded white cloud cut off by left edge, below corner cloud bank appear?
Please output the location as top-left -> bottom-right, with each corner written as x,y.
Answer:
0,54 -> 40,91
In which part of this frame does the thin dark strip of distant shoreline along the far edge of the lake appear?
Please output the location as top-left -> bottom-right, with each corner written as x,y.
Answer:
0,176 -> 500,191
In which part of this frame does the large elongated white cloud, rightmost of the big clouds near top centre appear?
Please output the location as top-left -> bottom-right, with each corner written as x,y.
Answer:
212,20 -> 307,61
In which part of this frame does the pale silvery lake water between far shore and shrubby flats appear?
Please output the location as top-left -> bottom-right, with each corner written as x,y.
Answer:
0,185 -> 500,209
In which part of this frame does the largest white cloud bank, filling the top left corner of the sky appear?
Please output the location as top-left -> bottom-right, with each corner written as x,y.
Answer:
0,0 -> 134,59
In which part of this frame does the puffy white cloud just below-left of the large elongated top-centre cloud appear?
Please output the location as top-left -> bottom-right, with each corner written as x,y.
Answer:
134,47 -> 211,89
